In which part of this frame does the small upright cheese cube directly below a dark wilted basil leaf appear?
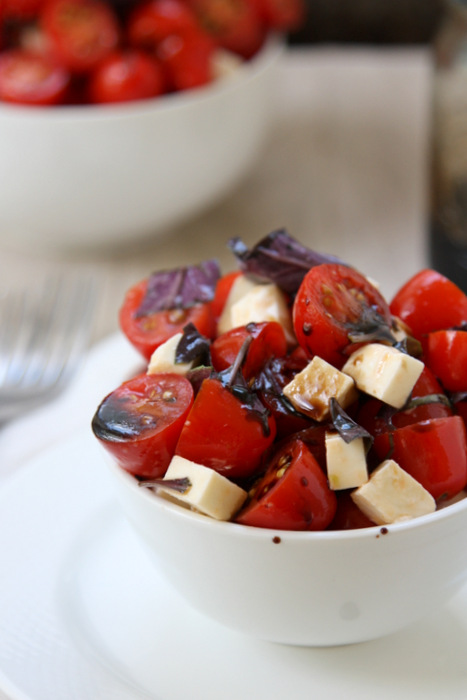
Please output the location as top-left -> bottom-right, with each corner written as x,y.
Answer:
324,431 -> 368,491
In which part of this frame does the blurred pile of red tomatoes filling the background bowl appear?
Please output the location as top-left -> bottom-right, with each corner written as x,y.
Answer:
0,0 -> 304,106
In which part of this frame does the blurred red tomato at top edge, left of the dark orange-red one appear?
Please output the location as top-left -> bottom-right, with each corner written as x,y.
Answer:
127,0 -> 199,51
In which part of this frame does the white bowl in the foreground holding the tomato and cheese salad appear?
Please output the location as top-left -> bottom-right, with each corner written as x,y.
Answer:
110,464 -> 467,646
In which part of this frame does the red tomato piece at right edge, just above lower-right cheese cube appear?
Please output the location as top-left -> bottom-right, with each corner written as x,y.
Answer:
374,416 -> 467,500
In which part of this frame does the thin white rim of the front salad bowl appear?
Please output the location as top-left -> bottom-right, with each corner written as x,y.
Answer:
107,458 -> 467,543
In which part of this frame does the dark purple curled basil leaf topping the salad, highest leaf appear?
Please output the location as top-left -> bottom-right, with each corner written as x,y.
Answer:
228,229 -> 344,296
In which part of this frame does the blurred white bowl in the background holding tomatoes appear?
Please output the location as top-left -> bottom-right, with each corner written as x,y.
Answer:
0,38 -> 282,249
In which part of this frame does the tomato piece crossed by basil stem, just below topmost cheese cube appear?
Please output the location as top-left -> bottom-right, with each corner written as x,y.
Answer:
211,321 -> 287,379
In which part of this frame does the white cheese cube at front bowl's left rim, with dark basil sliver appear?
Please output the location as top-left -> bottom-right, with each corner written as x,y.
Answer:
159,455 -> 248,520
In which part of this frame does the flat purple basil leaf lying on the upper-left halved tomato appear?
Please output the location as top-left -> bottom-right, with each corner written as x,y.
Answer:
136,260 -> 220,318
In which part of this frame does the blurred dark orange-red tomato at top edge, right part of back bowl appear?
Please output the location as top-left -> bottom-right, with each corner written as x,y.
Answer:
189,0 -> 265,58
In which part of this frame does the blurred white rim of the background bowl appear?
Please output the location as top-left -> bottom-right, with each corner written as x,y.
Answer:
0,33 -> 285,122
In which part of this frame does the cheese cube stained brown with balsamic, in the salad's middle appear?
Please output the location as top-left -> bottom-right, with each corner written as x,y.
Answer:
282,355 -> 357,421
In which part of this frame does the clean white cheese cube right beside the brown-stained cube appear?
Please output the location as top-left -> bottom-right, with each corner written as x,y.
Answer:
342,343 -> 424,408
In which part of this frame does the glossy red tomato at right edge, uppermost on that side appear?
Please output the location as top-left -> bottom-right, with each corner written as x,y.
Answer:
390,270 -> 467,340
